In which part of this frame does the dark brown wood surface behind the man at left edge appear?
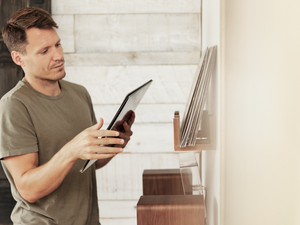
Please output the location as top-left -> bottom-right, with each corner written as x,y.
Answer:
0,0 -> 51,225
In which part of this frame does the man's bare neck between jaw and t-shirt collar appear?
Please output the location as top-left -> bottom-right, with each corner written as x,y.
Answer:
24,75 -> 61,96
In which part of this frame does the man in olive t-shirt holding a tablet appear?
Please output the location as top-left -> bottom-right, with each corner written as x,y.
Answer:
0,8 -> 134,225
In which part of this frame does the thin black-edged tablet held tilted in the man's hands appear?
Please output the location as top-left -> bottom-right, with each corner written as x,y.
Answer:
80,80 -> 152,173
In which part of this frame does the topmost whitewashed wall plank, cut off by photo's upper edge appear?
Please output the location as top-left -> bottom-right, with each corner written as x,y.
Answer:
52,0 -> 201,14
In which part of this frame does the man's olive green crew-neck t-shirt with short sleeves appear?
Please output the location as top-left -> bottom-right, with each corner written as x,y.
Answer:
0,79 -> 99,225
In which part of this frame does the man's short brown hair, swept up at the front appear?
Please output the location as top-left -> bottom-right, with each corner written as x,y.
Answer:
2,7 -> 58,54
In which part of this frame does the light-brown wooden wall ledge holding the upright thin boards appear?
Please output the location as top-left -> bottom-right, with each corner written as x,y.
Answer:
173,111 -> 216,151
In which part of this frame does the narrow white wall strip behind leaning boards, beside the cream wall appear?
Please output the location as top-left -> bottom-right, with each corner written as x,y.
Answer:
202,0 -> 221,225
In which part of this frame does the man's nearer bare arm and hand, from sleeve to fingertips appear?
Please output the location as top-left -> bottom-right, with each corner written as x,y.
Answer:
4,119 -> 124,203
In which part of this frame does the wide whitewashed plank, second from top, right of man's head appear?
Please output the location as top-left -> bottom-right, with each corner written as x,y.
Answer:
75,14 -> 201,52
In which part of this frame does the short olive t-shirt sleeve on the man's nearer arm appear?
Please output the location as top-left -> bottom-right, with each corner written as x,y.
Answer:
0,98 -> 38,159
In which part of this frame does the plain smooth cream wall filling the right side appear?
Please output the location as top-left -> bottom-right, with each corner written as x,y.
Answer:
221,0 -> 300,225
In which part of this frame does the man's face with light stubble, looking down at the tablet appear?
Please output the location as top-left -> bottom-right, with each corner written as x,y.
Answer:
22,28 -> 65,81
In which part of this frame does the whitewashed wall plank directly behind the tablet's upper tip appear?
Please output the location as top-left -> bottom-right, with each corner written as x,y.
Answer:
65,65 -> 196,104
